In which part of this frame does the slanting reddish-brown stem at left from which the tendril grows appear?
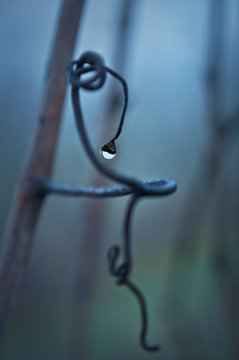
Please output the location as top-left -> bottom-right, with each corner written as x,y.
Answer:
0,0 -> 84,339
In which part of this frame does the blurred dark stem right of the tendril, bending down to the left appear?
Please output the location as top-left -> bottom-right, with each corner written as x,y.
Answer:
170,0 -> 226,256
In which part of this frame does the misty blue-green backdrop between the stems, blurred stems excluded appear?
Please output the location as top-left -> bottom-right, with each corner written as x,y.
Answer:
0,0 -> 239,360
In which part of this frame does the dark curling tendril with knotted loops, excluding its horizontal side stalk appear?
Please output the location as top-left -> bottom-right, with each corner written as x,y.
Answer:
68,51 -> 176,351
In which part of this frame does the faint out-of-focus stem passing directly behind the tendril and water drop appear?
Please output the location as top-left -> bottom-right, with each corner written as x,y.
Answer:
69,0 -> 134,359
